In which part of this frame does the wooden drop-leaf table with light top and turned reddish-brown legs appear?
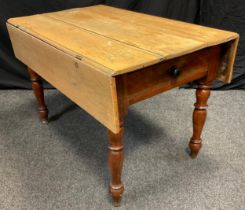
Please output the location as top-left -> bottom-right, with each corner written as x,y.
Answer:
7,5 -> 239,206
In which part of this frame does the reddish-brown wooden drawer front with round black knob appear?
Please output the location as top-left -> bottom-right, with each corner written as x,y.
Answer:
123,49 -> 209,104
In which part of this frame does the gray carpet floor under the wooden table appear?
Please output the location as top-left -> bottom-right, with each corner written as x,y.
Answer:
0,90 -> 245,210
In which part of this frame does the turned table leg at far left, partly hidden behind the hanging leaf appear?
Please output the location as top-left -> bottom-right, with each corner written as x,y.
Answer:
28,68 -> 48,123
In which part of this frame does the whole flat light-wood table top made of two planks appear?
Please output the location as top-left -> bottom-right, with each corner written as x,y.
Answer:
8,5 -> 239,76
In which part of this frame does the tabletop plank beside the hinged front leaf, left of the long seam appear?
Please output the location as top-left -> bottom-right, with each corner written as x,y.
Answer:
8,15 -> 161,75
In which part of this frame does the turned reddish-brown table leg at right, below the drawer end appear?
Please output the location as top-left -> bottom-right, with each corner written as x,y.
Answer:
189,81 -> 210,159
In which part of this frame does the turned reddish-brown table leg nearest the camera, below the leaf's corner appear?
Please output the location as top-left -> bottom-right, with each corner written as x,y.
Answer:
108,128 -> 124,206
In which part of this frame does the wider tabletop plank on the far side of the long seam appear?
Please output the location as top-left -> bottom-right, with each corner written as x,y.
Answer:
45,5 -> 238,60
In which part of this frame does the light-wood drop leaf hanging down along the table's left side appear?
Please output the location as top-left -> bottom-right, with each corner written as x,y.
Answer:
7,24 -> 120,133
